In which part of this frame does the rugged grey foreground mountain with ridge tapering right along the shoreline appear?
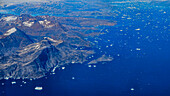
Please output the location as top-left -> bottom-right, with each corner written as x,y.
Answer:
0,34 -> 94,79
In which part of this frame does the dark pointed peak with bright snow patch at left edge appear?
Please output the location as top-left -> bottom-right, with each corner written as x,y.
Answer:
0,27 -> 33,53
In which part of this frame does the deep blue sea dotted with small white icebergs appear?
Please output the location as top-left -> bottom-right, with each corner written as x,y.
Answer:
0,0 -> 170,96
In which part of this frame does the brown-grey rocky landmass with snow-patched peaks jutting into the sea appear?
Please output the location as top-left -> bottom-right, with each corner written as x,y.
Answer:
0,14 -> 115,79
